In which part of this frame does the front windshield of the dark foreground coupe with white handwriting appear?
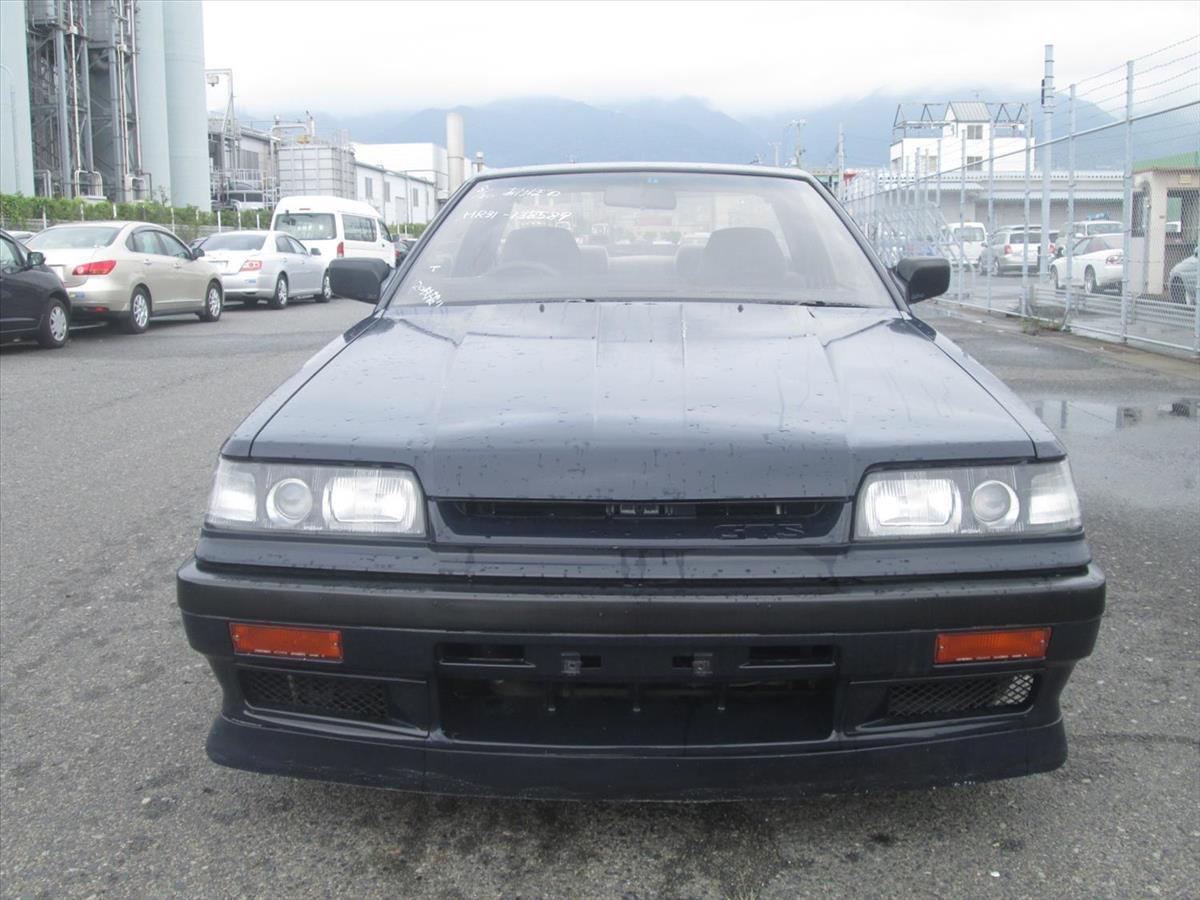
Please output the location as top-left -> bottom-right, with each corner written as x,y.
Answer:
391,172 -> 894,308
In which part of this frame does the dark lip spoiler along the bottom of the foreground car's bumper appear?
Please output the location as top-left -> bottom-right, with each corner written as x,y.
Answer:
206,715 -> 1067,802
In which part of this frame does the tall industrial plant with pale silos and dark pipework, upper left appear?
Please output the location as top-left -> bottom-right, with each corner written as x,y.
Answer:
0,0 -> 210,209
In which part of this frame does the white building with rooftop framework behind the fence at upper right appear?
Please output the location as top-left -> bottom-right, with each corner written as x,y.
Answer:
888,100 -> 1030,176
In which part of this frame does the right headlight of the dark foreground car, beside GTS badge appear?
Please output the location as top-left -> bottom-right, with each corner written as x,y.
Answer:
854,460 -> 1080,540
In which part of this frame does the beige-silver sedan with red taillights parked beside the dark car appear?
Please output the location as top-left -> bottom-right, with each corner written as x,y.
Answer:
25,222 -> 224,335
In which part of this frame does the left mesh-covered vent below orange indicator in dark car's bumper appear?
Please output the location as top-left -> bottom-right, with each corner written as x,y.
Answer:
238,668 -> 388,722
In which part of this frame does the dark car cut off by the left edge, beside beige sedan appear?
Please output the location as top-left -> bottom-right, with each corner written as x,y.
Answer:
0,232 -> 71,349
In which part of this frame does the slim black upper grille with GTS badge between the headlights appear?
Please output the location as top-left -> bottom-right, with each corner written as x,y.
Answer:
438,500 -> 845,540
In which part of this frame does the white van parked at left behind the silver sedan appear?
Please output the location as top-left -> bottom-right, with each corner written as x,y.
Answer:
271,197 -> 396,265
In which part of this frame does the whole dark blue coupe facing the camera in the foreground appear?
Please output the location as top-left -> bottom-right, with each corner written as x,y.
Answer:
178,164 -> 1104,799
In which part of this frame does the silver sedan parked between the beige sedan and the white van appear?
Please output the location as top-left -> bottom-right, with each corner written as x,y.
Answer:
200,232 -> 332,310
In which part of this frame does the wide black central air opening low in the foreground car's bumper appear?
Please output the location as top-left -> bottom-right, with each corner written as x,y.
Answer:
438,678 -> 834,746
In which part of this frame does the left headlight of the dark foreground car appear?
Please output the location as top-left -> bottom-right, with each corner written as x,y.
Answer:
205,460 -> 425,536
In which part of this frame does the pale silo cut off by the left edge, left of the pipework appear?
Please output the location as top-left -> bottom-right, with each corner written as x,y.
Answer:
0,2 -> 34,197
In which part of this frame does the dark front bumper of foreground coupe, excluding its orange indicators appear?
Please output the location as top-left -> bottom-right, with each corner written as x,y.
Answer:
178,560 -> 1104,799
